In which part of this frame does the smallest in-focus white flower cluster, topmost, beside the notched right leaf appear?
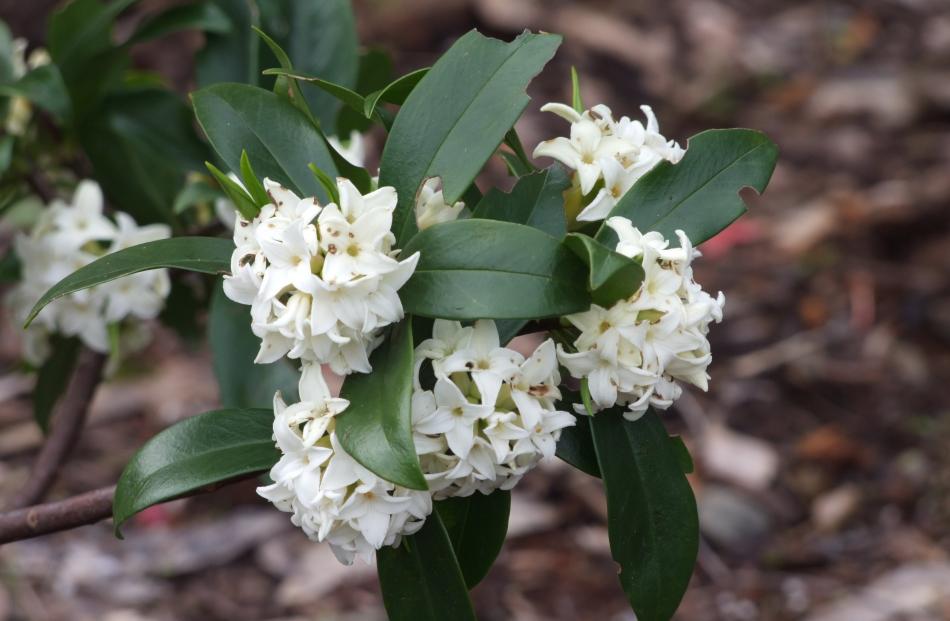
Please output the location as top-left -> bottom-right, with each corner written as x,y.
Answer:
534,103 -> 685,221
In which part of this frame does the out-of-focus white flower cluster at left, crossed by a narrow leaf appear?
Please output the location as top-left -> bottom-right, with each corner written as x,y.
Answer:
8,181 -> 171,365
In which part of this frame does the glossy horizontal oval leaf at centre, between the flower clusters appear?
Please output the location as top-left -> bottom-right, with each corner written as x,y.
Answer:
399,219 -> 590,320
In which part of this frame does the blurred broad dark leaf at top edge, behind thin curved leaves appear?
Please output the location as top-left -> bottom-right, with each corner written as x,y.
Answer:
260,0 -> 359,128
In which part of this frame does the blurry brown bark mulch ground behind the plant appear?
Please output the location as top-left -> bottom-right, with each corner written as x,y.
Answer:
0,0 -> 950,621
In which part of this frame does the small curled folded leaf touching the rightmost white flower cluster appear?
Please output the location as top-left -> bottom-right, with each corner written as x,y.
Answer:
564,233 -> 643,308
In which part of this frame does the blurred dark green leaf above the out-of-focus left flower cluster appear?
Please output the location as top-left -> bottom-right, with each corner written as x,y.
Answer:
79,89 -> 210,226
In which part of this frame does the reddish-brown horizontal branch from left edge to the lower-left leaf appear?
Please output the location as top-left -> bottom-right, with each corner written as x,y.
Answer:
0,485 -> 115,544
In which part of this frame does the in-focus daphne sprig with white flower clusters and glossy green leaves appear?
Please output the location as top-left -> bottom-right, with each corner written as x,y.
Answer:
3,3 -> 776,621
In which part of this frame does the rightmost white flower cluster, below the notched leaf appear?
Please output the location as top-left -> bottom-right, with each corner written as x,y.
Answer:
558,217 -> 725,420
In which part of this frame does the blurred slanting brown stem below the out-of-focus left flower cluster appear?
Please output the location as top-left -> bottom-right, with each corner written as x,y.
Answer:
10,349 -> 106,509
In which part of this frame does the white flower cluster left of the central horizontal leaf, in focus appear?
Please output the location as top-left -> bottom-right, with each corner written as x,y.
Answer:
224,178 -> 419,375
